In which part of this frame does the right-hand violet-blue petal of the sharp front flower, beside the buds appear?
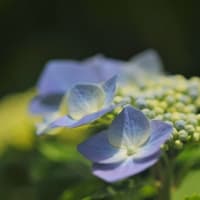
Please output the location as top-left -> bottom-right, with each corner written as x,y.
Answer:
135,120 -> 173,158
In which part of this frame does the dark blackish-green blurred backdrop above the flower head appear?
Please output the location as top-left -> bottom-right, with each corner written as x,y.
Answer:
0,0 -> 200,96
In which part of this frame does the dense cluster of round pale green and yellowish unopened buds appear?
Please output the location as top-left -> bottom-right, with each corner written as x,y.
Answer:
118,75 -> 200,150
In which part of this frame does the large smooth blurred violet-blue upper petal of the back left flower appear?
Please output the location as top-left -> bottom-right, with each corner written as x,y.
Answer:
38,57 -> 118,94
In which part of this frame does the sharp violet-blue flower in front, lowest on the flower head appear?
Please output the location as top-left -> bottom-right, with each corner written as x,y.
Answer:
78,105 -> 172,182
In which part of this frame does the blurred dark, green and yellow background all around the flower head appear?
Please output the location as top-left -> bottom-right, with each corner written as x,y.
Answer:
0,0 -> 200,200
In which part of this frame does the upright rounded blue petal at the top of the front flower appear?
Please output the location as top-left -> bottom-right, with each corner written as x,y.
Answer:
108,106 -> 150,149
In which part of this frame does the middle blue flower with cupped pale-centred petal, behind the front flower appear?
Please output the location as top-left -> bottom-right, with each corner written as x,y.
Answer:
50,76 -> 126,128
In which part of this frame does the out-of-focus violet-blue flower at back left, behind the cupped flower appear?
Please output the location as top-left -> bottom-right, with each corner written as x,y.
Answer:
30,56 -> 119,116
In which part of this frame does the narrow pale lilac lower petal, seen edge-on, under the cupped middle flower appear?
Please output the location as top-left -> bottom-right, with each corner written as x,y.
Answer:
51,104 -> 118,128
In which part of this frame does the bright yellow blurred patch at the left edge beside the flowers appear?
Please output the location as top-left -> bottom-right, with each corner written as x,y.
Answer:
0,91 -> 34,153
